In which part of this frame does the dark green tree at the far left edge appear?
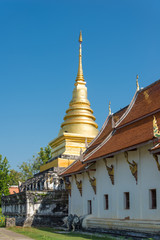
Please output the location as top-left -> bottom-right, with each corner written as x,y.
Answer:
0,155 -> 10,205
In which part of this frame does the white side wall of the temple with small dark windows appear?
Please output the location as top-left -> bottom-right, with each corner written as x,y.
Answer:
70,144 -> 160,220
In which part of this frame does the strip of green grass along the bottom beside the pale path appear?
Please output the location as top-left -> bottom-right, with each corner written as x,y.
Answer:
9,227 -> 121,240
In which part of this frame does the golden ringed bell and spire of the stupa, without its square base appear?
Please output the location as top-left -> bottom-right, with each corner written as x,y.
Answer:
58,32 -> 98,137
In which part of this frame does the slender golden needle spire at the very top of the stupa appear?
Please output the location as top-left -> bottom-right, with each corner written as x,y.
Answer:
76,31 -> 84,82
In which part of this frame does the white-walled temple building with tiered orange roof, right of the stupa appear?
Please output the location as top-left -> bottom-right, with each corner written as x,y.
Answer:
61,78 -> 160,232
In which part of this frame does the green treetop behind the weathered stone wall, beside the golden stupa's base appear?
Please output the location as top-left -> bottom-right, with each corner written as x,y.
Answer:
19,146 -> 51,181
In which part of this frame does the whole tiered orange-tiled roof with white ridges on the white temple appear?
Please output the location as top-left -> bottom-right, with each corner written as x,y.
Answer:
62,80 -> 160,176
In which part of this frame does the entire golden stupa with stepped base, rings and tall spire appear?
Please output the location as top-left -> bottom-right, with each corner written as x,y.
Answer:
40,32 -> 98,172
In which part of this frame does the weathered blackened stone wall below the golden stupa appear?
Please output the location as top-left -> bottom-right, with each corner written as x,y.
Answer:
2,190 -> 68,226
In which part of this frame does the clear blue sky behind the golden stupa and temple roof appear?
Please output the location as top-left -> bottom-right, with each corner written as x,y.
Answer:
0,0 -> 160,168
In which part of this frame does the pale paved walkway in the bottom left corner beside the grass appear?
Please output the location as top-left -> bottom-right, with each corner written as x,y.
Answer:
0,228 -> 33,240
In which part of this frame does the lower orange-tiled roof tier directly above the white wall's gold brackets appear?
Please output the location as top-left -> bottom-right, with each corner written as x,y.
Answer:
84,112 -> 160,161
